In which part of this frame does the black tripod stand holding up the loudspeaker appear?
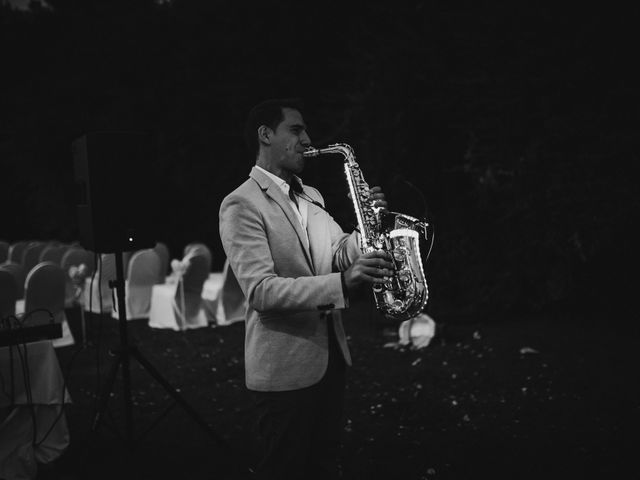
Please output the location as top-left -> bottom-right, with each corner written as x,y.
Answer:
91,251 -> 248,472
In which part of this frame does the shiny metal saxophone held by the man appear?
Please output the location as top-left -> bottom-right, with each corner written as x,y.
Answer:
303,143 -> 429,321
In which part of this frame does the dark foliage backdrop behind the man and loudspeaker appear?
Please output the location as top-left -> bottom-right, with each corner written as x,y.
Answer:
0,0 -> 640,313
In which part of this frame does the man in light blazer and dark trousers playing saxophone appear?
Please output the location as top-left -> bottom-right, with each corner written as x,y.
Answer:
219,100 -> 394,480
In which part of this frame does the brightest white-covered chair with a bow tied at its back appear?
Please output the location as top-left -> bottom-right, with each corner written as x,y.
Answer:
149,251 -> 211,330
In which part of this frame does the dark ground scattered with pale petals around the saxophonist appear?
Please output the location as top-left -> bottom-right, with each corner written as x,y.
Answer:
39,301 -> 640,480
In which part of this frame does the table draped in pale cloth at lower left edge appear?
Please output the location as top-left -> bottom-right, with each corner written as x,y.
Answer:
0,340 -> 71,479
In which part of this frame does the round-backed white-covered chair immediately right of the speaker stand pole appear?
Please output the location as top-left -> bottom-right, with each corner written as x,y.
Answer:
111,248 -> 160,320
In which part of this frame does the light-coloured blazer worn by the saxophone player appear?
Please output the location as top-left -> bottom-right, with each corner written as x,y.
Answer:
220,167 -> 360,391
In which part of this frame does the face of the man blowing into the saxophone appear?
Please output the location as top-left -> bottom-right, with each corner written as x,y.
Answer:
271,108 -> 311,175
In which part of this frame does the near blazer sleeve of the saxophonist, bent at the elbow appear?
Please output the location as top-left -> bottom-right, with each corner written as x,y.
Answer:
219,194 -> 349,313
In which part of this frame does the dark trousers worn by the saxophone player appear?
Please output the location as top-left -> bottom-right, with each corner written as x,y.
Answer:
251,322 -> 346,480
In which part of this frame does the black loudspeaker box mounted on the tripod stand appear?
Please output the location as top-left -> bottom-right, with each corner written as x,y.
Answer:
72,131 -> 158,253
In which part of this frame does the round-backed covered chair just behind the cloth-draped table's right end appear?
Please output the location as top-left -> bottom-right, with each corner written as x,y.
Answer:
17,262 -> 75,347
